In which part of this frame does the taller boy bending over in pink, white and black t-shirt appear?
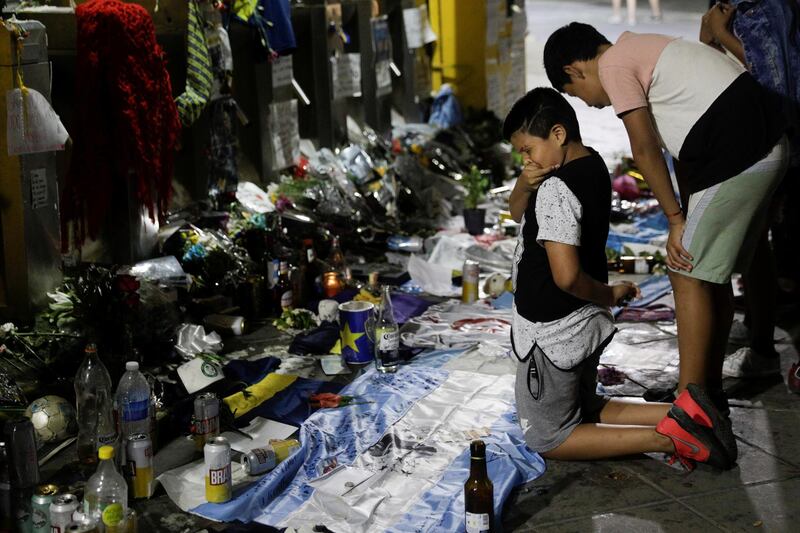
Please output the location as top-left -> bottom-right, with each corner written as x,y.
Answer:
544,22 -> 788,410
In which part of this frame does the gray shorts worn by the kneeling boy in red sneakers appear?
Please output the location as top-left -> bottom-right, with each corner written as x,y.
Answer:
514,335 -> 613,453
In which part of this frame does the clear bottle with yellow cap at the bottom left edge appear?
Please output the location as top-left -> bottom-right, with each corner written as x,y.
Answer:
83,446 -> 128,533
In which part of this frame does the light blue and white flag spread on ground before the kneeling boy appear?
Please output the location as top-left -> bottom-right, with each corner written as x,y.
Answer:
166,350 -> 545,533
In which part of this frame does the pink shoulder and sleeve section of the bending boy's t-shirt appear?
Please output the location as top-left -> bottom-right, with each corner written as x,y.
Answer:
597,31 -> 676,115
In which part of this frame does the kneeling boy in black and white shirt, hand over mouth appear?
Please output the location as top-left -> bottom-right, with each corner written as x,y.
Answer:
510,87 -> 737,468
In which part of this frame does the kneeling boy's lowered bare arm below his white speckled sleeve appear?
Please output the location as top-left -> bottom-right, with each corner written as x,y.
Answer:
544,241 -> 639,307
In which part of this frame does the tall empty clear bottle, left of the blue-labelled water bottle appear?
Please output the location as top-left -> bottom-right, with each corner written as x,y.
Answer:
74,344 -> 117,464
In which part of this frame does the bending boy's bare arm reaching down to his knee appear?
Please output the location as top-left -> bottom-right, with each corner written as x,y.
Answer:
621,107 -> 692,271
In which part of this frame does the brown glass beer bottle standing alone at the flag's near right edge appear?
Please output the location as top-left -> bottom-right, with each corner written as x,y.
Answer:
464,440 -> 494,533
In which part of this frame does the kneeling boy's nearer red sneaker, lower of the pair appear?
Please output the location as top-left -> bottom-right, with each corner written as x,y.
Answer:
656,405 -> 731,470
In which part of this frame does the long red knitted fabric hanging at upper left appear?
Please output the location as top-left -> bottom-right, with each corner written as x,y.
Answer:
61,0 -> 180,250
